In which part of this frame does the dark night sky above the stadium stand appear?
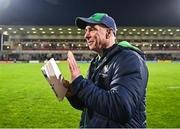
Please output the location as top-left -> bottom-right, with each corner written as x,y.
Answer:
0,0 -> 180,27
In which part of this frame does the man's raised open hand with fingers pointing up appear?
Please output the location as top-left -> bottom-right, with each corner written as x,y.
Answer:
67,51 -> 81,81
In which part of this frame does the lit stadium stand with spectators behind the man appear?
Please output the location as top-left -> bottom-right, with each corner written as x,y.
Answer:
0,25 -> 180,62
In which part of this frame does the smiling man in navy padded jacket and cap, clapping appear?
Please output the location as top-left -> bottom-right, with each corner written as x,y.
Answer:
67,13 -> 148,128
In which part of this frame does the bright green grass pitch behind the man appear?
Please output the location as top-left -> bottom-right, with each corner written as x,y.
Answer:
0,63 -> 180,128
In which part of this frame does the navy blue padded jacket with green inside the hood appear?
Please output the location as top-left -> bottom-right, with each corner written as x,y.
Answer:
68,44 -> 148,128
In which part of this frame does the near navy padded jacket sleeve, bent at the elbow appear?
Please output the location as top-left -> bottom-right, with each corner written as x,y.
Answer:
72,54 -> 147,123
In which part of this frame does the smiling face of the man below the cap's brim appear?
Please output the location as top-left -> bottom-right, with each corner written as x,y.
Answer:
84,25 -> 107,52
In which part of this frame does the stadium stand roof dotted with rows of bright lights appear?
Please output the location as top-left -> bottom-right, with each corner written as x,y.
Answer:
0,25 -> 180,39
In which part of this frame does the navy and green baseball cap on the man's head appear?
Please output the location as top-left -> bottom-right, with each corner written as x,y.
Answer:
75,13 -> 117,34
